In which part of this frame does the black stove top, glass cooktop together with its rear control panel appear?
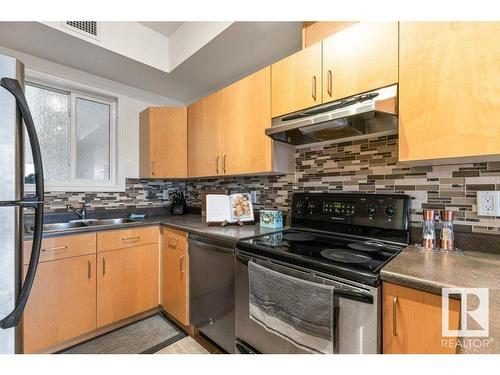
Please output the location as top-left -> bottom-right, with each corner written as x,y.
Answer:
237,193 -> 410,286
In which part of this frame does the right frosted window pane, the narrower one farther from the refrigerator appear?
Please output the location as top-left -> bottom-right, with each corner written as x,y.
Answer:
76,98 -> 110,181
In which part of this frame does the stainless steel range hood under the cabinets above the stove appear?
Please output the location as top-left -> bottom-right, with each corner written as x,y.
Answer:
266,85 -> 398,145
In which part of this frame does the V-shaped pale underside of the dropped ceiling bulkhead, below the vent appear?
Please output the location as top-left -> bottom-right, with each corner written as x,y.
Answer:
0,22 -> 302,103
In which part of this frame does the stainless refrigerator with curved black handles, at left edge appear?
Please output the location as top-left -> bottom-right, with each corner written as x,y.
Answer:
0,54 -> 44,354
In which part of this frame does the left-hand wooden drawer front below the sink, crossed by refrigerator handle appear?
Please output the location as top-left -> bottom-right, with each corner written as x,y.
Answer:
23,233 -> 96,265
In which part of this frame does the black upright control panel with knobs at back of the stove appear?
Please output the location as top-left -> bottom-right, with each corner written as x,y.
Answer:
291,193 -> 410,230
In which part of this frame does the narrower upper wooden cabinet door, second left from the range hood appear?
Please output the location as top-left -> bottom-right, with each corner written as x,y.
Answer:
188,91 -> 224,177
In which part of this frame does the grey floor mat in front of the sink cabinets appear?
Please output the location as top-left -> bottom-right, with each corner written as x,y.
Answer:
61,313 -> 186,354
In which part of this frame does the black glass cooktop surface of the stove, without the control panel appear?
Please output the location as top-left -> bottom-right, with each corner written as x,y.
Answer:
238,229 -> 404,285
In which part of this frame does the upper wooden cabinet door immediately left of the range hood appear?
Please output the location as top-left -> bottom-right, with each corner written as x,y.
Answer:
222,67 -> 272,174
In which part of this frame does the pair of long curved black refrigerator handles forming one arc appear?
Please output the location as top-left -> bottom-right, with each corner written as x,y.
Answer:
0,78 -> 44,329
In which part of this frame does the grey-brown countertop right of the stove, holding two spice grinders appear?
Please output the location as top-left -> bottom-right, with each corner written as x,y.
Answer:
380,246 -> 500,353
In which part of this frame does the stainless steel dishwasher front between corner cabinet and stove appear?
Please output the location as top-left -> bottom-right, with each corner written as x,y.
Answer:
188,234 -> 235,353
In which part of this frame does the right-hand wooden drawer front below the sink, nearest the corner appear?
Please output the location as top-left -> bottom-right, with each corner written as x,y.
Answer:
97,227 -> 158,252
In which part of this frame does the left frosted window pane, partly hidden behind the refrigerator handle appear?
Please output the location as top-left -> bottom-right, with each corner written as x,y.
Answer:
25,85 -> 71,183
